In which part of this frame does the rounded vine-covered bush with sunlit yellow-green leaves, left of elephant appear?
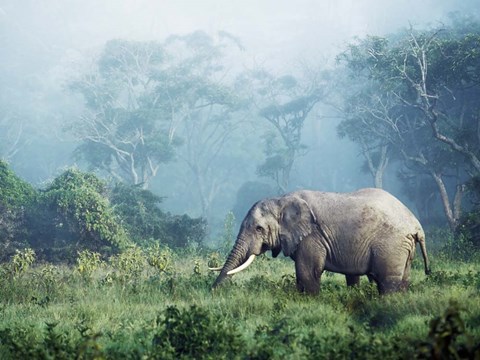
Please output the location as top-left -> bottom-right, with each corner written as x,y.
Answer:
32,169 -> 129,260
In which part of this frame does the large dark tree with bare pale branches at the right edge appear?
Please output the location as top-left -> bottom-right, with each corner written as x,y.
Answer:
342,17 -> 480,230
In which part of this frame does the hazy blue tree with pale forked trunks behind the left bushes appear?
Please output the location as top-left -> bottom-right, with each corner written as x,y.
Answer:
70,40 -> 179,188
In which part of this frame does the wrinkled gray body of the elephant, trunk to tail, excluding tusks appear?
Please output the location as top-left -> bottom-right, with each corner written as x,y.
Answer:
213,189 -> 429,294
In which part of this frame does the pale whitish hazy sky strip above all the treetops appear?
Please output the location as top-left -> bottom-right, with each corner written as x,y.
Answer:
0,0 -> 480,71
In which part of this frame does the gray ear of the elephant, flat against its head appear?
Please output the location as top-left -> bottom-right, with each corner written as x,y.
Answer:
279,196 -> 317,256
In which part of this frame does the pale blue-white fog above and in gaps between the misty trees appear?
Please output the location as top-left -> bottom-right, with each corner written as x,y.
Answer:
0,0 -> 480,240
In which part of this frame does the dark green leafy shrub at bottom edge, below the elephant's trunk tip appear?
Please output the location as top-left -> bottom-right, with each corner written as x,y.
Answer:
153,305 -> 243,359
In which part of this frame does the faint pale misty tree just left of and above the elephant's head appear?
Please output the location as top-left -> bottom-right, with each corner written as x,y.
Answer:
155,31 -> 246,218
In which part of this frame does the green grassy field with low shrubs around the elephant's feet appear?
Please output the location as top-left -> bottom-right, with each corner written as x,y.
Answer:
0,243 -> 480,359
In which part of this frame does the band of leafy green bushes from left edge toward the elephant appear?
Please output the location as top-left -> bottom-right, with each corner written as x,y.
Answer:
0,161 -> 206,266
